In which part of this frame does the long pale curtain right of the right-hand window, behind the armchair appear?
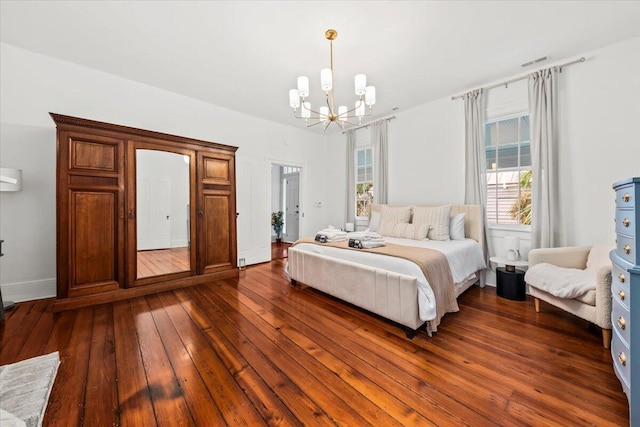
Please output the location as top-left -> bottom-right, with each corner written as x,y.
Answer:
529,67 -> 565,249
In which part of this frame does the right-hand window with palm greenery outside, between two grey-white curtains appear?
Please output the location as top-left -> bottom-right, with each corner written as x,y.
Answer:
485,114 -> 532,225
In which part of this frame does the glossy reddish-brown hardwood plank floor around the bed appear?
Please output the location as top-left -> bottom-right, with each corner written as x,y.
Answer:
0,259 -> 629,426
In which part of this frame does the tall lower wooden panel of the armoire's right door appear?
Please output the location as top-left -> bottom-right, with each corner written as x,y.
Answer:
201,193 -> 235,273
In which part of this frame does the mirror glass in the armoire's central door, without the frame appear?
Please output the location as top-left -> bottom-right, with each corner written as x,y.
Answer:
136,149 -> 191,278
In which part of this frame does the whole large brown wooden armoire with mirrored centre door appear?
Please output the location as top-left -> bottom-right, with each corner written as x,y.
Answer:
51,113 -> 238,311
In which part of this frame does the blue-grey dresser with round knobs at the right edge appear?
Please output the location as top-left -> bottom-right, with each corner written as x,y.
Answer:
611,178 -> 640,426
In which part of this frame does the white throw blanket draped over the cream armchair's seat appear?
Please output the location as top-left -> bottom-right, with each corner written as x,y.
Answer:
524,262 -> 597,298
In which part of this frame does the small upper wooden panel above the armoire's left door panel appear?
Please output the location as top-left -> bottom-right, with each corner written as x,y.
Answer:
69,134 -> 123,174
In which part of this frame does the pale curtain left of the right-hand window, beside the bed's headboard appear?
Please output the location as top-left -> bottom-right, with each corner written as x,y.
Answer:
462,89 -> 493,265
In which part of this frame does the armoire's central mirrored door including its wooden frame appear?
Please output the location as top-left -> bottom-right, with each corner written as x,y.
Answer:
128,142 -> 196,286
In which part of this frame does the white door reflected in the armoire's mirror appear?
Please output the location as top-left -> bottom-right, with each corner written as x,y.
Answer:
136,179 -> 171,251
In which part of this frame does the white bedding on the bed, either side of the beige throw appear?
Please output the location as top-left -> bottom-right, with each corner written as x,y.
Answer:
296,237 -> 486,322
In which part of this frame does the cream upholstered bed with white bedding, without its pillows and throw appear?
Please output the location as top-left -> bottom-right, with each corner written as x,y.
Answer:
286,205 -> 486,338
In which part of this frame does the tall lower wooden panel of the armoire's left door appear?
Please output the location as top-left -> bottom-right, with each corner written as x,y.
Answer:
69,190 -> 120,296
